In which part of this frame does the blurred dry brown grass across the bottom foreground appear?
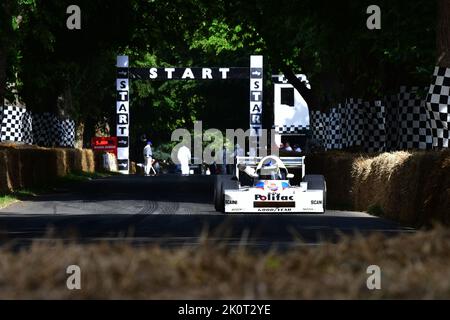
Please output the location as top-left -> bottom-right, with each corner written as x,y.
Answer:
0,226 -> 450,299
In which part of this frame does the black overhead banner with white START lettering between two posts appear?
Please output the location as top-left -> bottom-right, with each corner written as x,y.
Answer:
126,67 -> 249,81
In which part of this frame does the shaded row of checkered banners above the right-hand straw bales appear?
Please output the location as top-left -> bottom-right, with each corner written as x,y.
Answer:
311,87 -> 442,152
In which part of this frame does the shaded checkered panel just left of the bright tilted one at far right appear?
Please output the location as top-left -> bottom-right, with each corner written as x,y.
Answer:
397,87 -> 432,150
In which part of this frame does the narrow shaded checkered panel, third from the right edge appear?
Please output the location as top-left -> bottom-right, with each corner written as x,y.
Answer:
364,101 -> 386,152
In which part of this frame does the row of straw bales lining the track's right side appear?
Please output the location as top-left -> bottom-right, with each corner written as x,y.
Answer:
306,150 -> 450,226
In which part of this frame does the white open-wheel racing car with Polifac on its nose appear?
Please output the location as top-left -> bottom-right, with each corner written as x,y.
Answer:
214,155 -> 327,213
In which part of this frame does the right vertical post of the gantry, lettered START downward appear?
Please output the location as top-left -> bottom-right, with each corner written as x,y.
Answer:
250,56 -> 264,156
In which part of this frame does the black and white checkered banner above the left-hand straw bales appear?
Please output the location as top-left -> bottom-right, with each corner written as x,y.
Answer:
0,106 -> 75,147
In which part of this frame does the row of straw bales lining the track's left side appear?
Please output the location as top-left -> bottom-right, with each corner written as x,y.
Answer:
0,144 -> 95,193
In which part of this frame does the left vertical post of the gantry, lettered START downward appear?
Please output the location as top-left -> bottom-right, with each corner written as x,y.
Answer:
116,56 -> 130,174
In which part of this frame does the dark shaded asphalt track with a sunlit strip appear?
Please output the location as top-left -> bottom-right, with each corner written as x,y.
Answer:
0,175 -> 413,249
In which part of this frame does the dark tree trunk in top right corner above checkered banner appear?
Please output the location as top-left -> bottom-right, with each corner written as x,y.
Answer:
436,0 -> 450,68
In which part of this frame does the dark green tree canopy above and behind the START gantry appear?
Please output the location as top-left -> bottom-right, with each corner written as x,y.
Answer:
0,0 -> 437,151
